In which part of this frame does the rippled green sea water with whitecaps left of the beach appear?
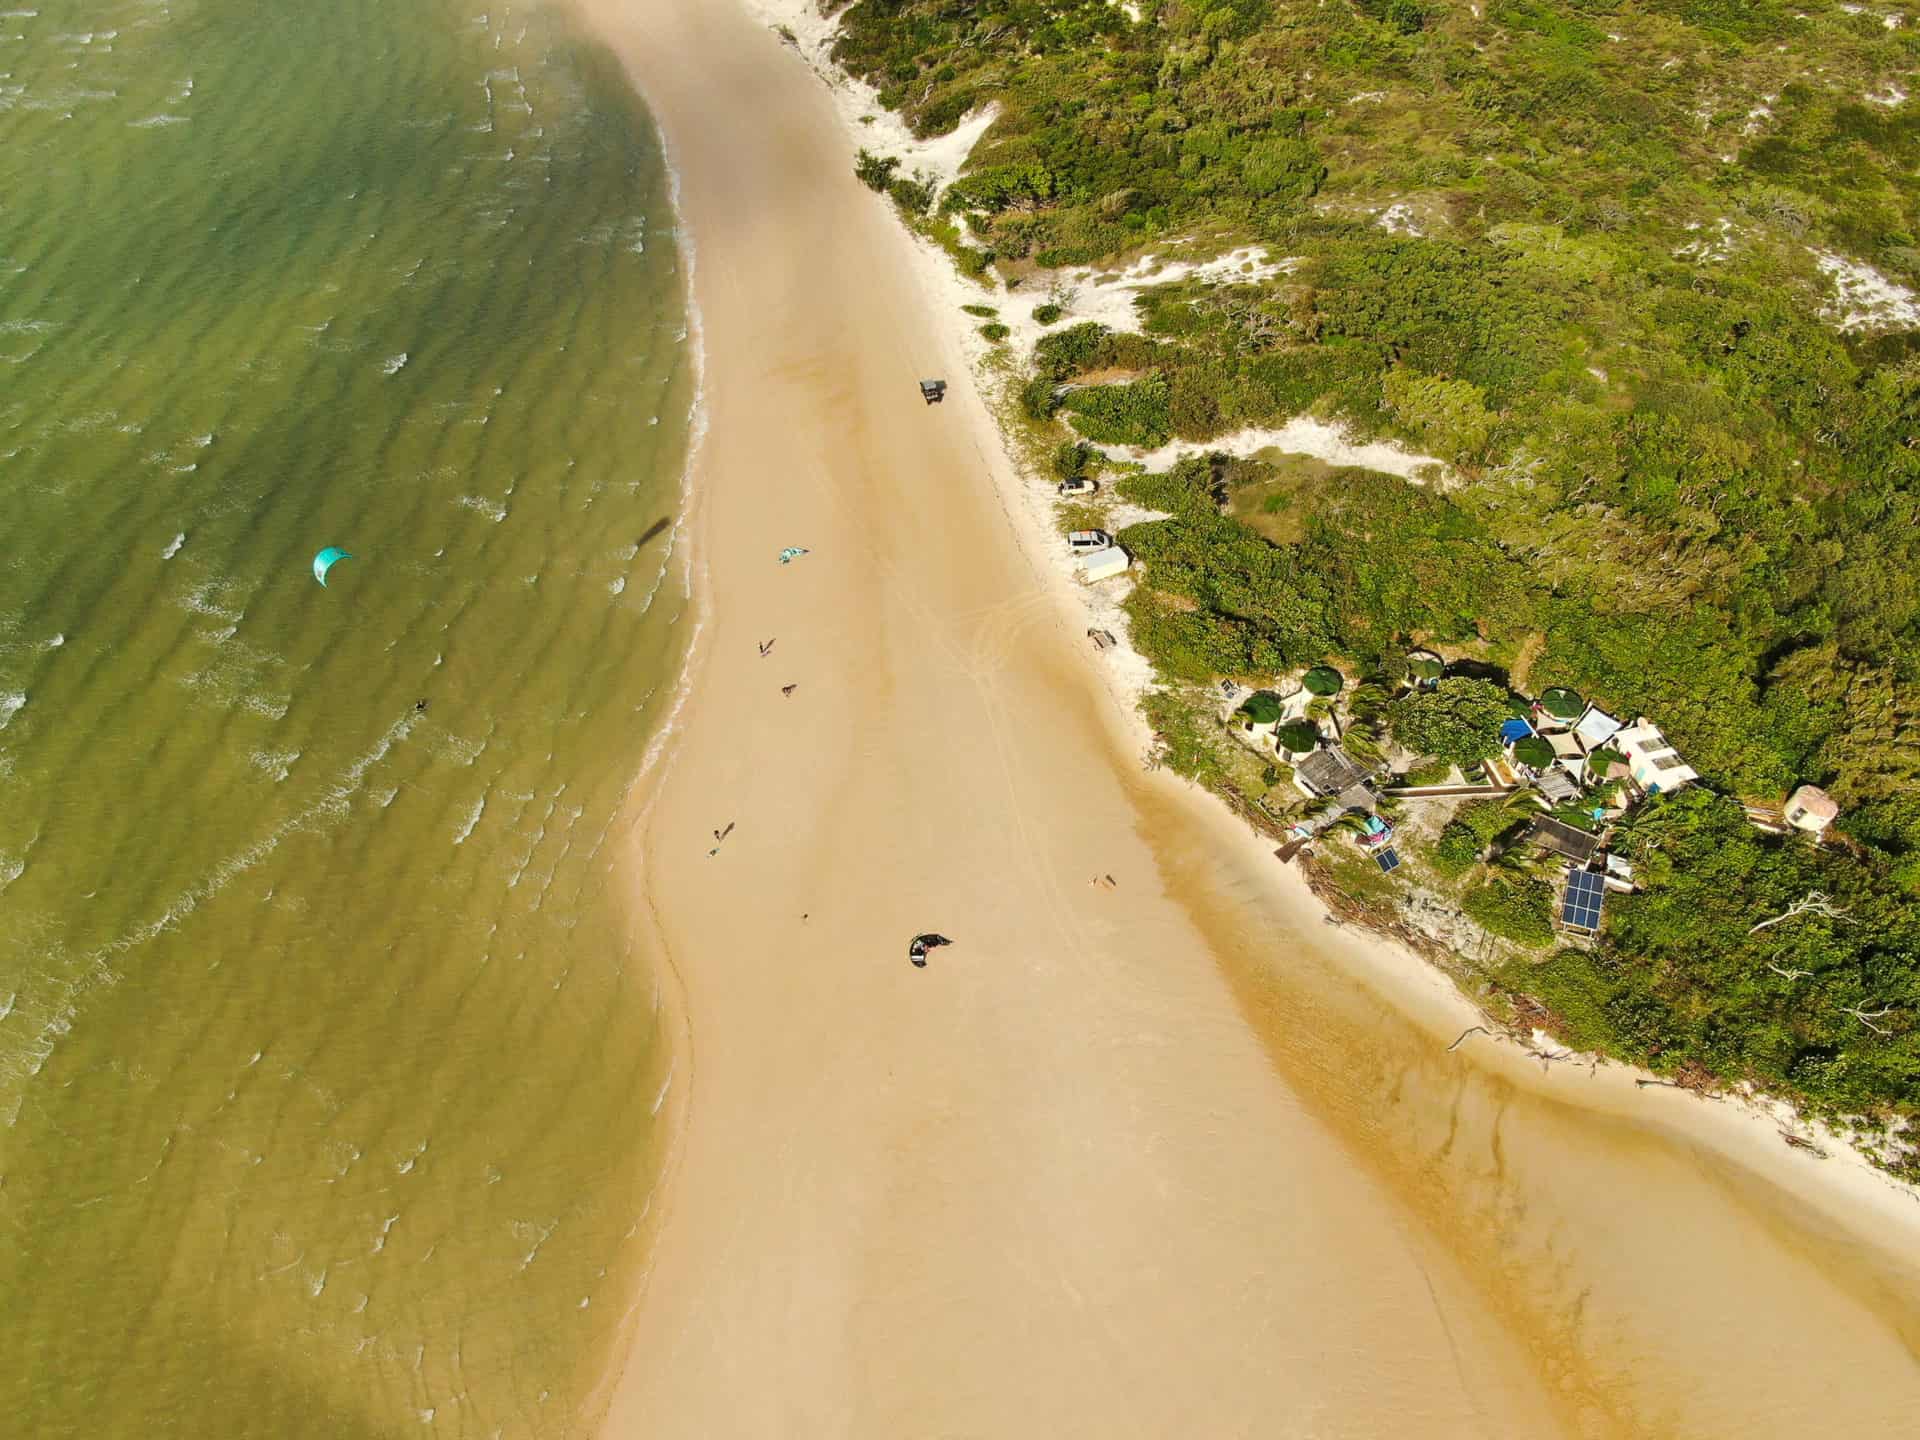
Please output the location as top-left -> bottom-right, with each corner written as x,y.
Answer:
0,0 -> 695,1438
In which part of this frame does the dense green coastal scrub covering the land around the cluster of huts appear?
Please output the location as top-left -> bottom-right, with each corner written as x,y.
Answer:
837,0 -> 1920,1136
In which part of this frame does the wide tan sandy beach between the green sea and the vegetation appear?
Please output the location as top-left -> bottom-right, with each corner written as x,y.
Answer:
584,0 -> 1920,1436
